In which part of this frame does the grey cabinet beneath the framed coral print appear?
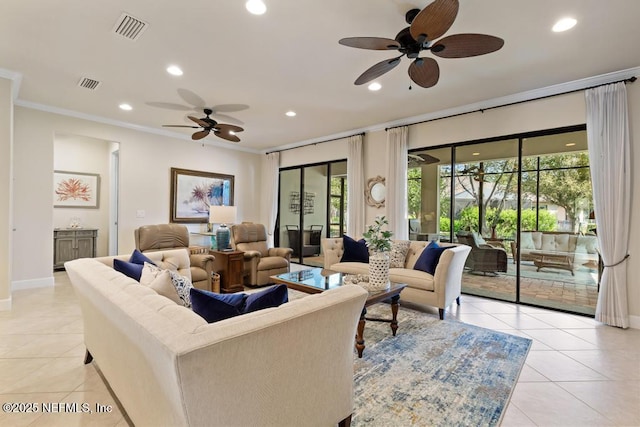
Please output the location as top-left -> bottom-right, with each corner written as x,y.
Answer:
53,228 -> 98,270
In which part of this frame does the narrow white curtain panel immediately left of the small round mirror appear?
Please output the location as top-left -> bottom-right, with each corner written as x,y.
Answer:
347,135 -> 365,239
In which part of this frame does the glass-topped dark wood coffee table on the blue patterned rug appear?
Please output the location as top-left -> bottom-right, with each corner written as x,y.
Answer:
271,268 -> 406,357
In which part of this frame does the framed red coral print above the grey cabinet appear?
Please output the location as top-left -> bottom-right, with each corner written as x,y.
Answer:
53,171 -> 100,209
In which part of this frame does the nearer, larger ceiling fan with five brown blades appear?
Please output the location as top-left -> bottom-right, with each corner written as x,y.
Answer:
338,0 -> 504,88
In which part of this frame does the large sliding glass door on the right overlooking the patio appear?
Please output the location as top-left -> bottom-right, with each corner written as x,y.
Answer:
408,128 -> 601,314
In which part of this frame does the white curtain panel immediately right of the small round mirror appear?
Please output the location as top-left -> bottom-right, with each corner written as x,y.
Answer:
385,126 -> 409,240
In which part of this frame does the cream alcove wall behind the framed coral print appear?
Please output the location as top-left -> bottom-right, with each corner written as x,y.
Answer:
53,133 -> 112,256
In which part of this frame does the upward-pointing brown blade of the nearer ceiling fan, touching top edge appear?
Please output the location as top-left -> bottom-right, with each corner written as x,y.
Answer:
411,0 -> 459,40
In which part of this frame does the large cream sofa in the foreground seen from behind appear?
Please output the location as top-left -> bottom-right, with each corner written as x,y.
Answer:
65,249 -> 366,426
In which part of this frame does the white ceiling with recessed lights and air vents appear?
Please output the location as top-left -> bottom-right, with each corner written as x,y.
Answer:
0,0 -> 640,151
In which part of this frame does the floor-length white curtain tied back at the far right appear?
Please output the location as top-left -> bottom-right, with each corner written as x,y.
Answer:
585,83 -> 631,328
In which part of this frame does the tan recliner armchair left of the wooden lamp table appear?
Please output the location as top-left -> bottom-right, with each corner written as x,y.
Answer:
134,224 -> 215,292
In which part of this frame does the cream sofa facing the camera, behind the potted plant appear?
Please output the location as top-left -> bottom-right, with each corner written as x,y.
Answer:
322,238 -> 471,319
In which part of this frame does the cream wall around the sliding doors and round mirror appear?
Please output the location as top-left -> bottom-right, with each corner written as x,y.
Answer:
282,88 -> 640,328
